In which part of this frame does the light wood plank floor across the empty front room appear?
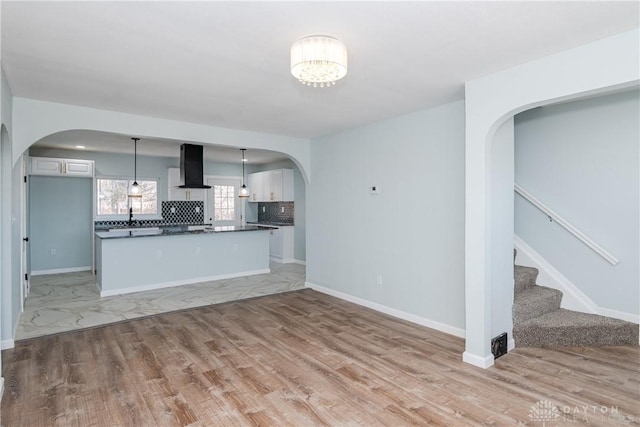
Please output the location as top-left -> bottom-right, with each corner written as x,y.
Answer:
1,290 -> 640,427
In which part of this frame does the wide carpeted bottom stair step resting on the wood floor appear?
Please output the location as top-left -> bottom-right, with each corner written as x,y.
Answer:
513,309 -> 639,347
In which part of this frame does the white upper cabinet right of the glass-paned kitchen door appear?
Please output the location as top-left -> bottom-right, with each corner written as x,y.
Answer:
247,169 -> 293,202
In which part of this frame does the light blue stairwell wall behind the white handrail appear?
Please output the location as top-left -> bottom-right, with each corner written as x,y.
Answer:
515,90 -> 640,314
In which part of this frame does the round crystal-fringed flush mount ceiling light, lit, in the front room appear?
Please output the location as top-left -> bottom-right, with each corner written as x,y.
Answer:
291,36 -> 347,87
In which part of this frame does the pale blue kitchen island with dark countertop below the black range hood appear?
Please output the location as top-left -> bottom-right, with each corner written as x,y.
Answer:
96,225 -> 270,296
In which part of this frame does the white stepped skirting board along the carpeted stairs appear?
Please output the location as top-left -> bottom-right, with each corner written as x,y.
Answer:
514,235 -> 640,323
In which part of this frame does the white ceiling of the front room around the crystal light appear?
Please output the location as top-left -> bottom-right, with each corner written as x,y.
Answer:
1,1 -> 640,145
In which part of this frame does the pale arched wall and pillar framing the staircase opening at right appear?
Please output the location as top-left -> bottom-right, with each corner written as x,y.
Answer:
463,29 -> 640,367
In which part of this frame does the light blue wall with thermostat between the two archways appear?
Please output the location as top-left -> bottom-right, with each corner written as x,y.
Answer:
307,101 -> 465,331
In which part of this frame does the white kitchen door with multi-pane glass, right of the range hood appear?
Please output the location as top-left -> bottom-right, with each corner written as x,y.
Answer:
205,178 -> 244,227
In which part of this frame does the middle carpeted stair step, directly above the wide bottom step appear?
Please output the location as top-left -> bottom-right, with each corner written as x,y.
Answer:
513,285 -> 562,325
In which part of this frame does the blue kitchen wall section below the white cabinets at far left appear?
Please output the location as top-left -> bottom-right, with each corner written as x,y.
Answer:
29,176 -> 93,273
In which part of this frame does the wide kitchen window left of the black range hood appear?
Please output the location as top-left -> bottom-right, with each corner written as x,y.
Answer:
96,178 -> 158,219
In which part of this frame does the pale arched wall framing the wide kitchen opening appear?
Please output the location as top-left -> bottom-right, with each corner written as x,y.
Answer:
0,103 -> 310,348
